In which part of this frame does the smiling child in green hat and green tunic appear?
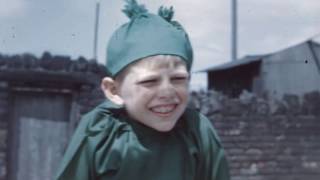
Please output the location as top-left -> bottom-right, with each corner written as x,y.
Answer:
56,0 -> 229,180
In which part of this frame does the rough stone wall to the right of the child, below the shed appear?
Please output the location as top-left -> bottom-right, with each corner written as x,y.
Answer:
193,91 -> 320,180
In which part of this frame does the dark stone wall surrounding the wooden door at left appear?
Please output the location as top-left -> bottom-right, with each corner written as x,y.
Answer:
0,54 -> 106,180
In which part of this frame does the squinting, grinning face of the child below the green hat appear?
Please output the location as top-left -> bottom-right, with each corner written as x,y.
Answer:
117,55 -> 189,131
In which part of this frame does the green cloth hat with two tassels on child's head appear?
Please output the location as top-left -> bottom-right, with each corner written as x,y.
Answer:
107,0 -> 193,77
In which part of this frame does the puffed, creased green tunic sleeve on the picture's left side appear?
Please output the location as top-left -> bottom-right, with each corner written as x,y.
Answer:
55,102 -> 132,180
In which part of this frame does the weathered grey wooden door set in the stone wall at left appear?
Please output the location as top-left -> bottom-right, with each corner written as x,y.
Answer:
9,91 -> 72,180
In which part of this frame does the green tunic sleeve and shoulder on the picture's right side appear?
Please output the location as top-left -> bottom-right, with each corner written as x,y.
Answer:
184,108 -> 230,180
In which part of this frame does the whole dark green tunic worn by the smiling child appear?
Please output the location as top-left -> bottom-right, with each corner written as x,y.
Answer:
56,102 -> 230,180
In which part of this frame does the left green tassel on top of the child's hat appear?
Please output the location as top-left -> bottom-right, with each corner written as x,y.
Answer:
122,0 -> 148,19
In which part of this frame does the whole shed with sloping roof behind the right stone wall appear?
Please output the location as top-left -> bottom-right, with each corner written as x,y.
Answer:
203,37 -> 320,97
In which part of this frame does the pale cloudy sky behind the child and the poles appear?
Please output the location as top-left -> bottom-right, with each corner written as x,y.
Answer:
0,0 -> 320,89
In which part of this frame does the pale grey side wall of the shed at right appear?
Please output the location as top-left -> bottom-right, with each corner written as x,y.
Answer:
261,43 -> 320,98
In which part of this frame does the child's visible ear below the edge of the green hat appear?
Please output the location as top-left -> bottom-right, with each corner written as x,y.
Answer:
101,77 -> 124,105
